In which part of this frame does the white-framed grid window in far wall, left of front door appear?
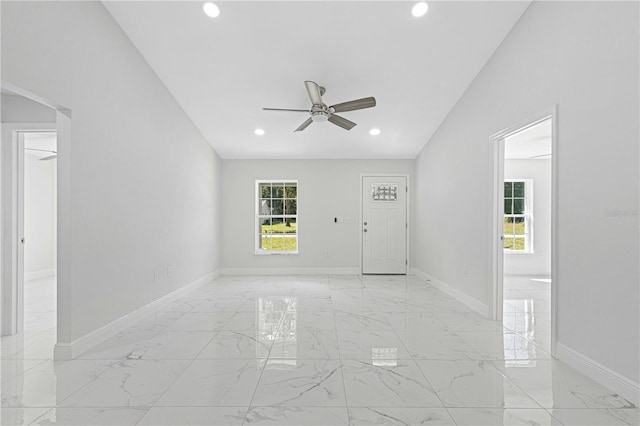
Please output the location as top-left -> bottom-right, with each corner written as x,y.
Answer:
256,180 -> 298,254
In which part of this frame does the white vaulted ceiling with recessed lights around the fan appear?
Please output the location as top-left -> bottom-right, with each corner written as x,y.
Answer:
104,1 -> 529,159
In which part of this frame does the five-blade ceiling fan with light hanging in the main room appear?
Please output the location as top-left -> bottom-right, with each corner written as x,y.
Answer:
262,81 -> 376,132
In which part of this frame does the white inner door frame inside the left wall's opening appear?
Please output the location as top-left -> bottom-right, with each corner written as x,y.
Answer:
0,123 -> 56,336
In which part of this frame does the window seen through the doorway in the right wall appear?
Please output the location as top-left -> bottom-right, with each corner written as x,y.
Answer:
504,179 -> 533,253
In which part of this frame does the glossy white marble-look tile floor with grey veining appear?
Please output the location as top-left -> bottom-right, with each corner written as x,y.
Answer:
2,276 -> 639,425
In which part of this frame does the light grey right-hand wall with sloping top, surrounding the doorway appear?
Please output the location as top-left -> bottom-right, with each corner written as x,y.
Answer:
414,2 -> 640,383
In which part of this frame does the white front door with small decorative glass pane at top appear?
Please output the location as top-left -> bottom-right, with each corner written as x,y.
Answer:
361,176 -> 407,274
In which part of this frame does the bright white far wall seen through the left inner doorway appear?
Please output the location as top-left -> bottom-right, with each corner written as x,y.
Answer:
24,154 -> 56,279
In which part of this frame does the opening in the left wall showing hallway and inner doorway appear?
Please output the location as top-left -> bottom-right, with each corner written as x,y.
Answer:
0,81 -> 71,359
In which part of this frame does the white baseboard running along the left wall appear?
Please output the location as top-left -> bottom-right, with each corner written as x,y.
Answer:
54,271 -> 219,359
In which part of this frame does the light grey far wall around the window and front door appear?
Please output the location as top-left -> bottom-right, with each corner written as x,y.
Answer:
222,160 -> 413,271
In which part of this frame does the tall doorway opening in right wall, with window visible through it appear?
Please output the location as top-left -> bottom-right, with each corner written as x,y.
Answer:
490,108 -> 557,362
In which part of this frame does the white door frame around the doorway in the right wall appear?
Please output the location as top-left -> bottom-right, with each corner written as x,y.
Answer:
489,105 -> 560,357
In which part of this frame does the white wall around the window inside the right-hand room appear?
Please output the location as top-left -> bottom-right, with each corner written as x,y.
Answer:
504,160 -> 551,277
